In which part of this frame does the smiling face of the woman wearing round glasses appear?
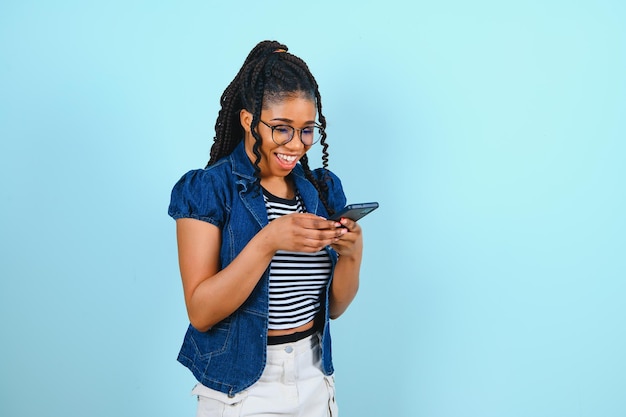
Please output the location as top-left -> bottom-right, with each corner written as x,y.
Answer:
240,94 -> 317,180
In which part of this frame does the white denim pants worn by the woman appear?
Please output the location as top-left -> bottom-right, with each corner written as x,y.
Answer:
192,334 -> 338,417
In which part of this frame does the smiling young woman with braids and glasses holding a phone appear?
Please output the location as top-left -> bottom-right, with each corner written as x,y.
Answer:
169,41 -> 363,416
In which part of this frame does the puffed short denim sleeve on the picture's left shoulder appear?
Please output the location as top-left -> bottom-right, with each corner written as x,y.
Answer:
168,169 -> 225,228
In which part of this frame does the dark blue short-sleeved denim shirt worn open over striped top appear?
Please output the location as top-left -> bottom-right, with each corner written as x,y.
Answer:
168,141 -> 346,396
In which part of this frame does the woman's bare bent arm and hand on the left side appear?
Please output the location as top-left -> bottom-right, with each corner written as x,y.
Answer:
176,213 -> 346,331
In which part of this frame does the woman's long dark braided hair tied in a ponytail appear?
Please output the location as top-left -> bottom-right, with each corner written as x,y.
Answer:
207,41 -> 334,215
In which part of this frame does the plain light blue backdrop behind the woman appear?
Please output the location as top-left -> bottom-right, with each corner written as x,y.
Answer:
0,0 -> 626,417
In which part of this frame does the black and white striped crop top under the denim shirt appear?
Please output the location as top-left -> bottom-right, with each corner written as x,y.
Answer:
263,189 -> 332,330
